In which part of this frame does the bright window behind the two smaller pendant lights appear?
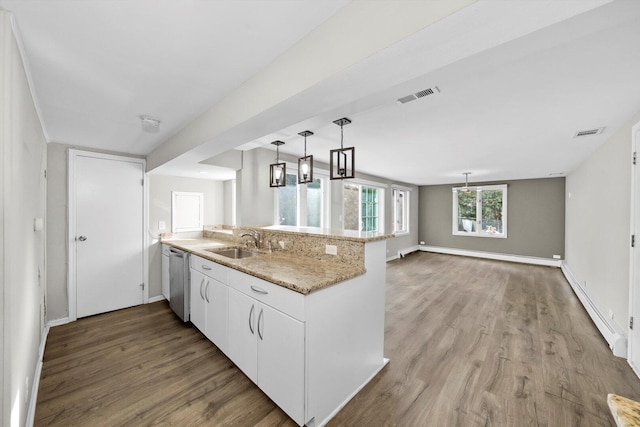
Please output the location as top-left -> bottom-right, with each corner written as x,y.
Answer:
275,165 -> 328,227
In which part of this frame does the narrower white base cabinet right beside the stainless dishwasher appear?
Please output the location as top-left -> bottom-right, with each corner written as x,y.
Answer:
191,256 -> 228,353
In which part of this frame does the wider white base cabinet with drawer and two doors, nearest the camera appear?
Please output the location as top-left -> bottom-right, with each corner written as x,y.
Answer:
227,271 -> 305,425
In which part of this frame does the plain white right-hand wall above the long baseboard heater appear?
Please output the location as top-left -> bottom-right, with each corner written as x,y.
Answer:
565,114 -> 640,331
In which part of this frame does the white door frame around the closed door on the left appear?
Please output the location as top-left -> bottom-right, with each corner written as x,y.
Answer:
67,149 -> 149,322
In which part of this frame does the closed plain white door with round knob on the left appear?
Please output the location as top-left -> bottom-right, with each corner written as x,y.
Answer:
69,150 -> 145,319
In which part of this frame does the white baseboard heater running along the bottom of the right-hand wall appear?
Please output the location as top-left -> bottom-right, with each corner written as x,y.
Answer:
560,262 -> 627,358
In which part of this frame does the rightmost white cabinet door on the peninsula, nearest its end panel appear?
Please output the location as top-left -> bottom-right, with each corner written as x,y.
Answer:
257,304 -> 305,425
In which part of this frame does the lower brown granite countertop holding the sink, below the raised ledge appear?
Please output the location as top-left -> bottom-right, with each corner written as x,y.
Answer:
161,238 -> 365,295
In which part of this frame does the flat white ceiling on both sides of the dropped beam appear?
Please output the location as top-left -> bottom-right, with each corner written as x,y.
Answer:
0,0 -> 640,184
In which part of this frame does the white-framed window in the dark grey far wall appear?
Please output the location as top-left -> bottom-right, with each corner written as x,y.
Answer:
453,185 -> 507,238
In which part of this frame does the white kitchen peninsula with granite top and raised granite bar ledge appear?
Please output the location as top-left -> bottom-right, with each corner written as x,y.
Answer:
163,226 -> 391,426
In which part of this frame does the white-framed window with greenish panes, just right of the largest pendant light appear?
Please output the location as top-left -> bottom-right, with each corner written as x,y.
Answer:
343,183 -> 384,233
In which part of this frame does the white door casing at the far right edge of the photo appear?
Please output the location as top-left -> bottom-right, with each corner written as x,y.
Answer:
627,123 -> 640,376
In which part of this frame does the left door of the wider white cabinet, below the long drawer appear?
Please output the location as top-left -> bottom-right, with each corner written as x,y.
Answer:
227,289 -> 259,383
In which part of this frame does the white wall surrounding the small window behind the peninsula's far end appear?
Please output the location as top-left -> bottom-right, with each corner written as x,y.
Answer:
148,175 -> 225,298
